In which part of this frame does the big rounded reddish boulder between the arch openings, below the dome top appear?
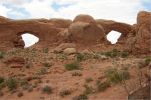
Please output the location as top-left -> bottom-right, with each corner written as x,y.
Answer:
68,22 -> 105,45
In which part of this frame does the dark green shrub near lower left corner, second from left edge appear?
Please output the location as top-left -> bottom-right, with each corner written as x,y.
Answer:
6,78 -> 17,91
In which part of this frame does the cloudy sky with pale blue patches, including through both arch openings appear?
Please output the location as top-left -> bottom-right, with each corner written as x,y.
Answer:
0,0 -> 151,46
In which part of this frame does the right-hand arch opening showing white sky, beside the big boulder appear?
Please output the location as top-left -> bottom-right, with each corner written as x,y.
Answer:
107,31 -> 121,44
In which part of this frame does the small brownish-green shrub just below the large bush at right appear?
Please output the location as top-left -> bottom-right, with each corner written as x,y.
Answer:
96,81 -> 110,92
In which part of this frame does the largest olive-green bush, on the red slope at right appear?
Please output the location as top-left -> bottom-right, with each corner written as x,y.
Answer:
106,68 -> 130,83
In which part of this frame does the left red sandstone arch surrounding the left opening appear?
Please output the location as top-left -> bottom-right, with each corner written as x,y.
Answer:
0,17 -> 62,49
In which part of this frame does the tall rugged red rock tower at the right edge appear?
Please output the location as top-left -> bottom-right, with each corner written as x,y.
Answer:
126,11 -> 151,54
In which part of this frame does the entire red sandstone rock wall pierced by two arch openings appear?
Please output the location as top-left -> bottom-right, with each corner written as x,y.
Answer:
0,11 -> 151,53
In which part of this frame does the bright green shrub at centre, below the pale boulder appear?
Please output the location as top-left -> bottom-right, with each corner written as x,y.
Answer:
65,62 -> 80,71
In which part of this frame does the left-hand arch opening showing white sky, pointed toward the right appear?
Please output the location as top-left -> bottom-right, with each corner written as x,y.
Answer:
21,33 -> 39,48
